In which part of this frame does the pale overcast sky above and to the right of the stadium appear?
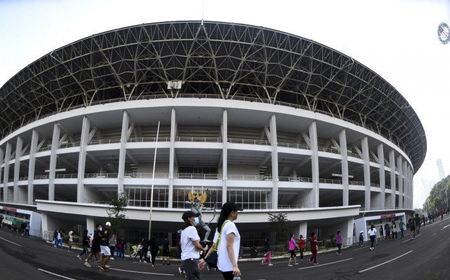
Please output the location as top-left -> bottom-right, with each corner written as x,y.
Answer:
0,0 -> 450,207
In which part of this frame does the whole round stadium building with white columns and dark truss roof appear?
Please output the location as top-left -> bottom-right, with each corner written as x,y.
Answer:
0,21 -> 427,244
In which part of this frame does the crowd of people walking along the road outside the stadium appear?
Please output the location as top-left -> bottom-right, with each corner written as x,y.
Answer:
38,209 -> 446,280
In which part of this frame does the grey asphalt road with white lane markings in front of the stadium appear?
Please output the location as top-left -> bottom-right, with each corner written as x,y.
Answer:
0,216 -> 450,280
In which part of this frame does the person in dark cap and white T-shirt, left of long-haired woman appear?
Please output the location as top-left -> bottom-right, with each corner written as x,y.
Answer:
180,211 -> 205,280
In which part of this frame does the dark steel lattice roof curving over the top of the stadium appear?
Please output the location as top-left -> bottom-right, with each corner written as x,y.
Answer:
0,21 -> 427,171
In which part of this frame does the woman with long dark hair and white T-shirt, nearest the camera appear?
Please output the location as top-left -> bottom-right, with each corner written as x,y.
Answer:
203,202 -> 241,280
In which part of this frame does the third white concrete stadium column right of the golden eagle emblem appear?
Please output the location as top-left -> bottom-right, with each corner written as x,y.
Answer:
309,122 -> 319,208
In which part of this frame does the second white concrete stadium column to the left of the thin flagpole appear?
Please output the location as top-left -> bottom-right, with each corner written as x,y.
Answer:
77,116 -> 91,203
